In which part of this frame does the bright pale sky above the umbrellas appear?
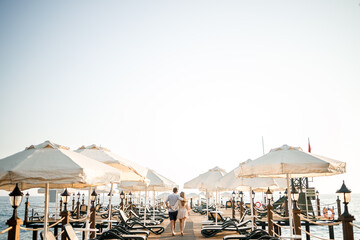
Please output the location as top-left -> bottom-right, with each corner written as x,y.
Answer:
0,0 -> 360,194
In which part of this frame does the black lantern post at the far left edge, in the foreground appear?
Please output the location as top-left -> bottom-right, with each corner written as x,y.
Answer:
6,184 -> 24,240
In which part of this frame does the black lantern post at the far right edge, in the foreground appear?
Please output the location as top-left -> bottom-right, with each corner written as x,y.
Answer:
336,181 -> 355,240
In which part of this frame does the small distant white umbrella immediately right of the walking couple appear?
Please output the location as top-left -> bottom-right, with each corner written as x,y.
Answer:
184,167 -> 226,224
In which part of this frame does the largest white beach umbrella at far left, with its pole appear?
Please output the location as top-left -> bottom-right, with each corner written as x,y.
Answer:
0,141 -> 121,240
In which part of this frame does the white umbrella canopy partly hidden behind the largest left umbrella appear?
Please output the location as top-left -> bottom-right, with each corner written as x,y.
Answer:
75,144 -> 147,181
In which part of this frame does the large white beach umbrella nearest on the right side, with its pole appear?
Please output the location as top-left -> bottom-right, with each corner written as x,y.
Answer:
235,145 -> 346,237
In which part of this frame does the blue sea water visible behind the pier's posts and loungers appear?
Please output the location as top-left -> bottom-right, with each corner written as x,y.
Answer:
0,194 -> 360,240
